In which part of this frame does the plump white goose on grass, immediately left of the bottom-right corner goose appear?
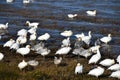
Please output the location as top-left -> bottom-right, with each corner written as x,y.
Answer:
88,66 -> 105,77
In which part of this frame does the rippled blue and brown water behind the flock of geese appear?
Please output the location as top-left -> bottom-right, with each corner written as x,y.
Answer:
0,0 -> 120,55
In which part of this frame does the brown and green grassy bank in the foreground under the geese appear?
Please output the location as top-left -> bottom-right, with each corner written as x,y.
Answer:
0,46 -> 118,80
